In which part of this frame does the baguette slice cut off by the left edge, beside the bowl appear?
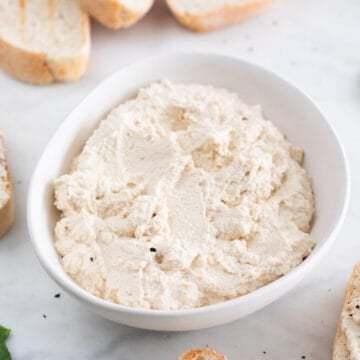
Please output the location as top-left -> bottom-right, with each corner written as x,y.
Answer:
0,133 -> 14,237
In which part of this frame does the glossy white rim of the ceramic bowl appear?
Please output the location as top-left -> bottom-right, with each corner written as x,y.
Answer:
26,51 -> 351,318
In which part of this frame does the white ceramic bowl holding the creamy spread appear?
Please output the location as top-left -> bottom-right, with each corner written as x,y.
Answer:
28,53 -> 349,331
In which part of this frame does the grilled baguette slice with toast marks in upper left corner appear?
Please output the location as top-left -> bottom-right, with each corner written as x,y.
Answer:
0,0 -> 90,84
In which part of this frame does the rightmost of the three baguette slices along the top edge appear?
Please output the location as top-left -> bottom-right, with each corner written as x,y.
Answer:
166,0 -> 272,32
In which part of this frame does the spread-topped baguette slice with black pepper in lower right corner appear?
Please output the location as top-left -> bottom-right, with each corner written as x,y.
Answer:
333,262 -> 360,360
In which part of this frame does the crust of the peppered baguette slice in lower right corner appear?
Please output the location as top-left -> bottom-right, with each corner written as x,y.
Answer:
333,262 -> 360,360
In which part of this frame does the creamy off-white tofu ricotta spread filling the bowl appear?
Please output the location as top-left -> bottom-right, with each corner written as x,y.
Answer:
55,81 -> 315,310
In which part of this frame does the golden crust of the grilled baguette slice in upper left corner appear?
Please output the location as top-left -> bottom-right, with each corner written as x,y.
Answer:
0,13 -> 90,85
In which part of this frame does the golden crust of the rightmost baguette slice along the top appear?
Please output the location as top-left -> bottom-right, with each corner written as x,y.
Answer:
166,0 -> 273,32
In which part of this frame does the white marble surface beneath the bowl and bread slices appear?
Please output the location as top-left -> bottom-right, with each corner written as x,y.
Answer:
0,0 -> 360,360
